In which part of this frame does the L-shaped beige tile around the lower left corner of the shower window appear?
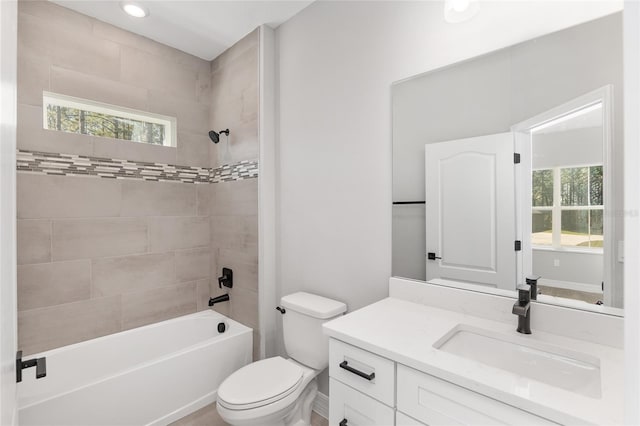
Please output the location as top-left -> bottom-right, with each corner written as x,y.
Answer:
16,104 -> 94,155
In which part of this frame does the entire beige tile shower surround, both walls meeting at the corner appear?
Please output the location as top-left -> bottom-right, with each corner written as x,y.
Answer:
18,1 -> 259,354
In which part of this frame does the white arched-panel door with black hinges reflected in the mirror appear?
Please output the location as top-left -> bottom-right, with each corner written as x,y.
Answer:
425,133 -> 516,290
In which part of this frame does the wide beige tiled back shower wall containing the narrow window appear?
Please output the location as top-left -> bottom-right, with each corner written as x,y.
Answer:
17,1 -> 212,354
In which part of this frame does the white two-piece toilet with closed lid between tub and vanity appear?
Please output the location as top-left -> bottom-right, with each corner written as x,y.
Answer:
216,292 -> 347,426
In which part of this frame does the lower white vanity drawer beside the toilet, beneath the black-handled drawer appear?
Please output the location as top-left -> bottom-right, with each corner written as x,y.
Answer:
329,378 -> 394,426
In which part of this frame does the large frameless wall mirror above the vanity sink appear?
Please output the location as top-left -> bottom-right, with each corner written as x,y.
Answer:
392,12 -> 624,314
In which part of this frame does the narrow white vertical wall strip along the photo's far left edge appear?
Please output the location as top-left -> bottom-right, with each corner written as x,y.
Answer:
0,1 -> 18,425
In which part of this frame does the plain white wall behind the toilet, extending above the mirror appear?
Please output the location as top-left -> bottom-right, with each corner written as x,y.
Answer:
276,1 -> 620,393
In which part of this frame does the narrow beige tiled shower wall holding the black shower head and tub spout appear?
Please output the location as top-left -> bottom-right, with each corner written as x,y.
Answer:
210,29 -> 260,359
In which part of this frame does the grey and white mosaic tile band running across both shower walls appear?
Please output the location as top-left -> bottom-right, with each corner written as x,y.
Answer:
16,150 -> 258,183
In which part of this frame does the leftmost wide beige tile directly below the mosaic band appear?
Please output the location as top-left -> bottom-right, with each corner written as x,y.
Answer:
17,173 -> 121,219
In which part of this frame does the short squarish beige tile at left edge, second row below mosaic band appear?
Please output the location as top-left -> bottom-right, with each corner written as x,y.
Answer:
17,220 -> 51,265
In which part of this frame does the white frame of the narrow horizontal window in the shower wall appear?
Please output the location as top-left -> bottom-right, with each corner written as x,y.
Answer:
42,91 -> 177,147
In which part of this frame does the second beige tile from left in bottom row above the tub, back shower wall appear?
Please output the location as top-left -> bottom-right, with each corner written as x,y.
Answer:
122,283 -> 196,330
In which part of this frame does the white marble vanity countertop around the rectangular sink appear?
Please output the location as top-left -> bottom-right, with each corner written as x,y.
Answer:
324,298 -> 624,425
